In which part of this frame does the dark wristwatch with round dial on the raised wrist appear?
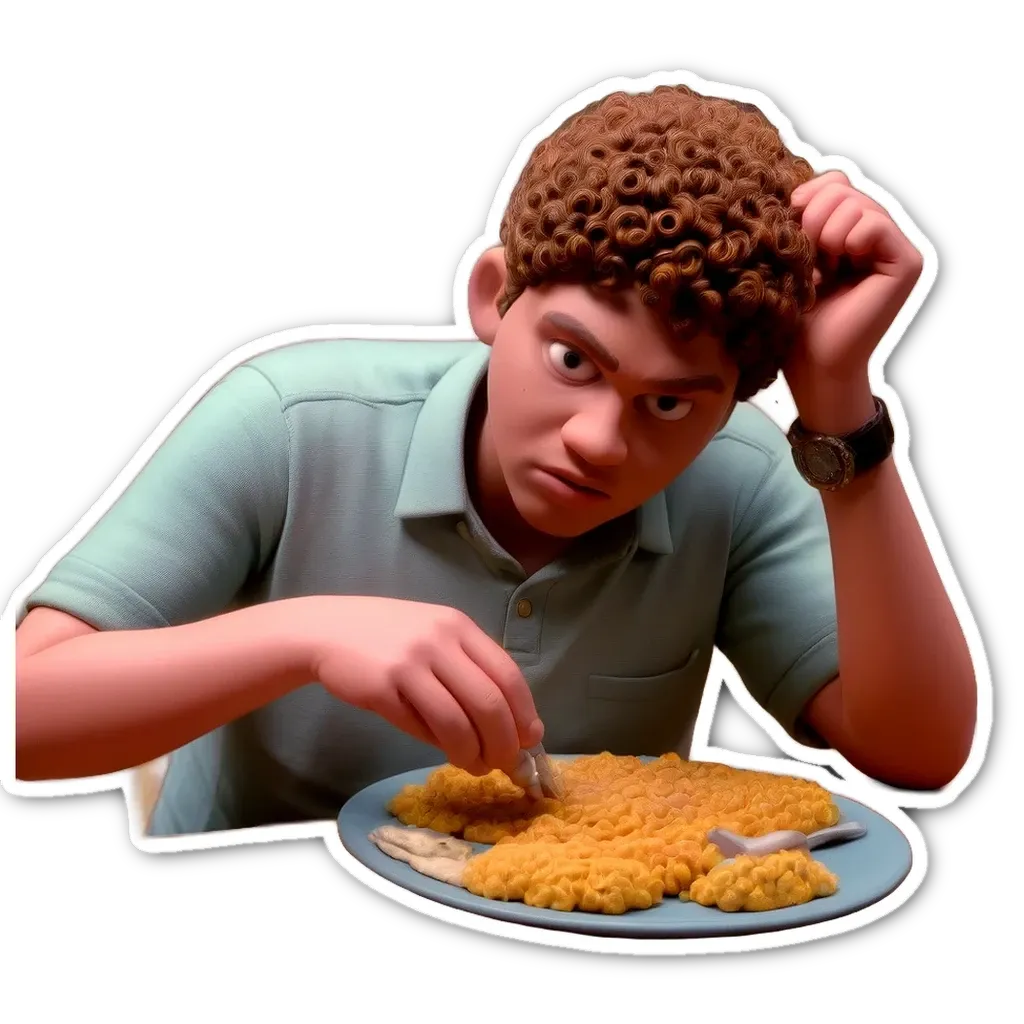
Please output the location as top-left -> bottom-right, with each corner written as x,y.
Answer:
786,397 -> 894,490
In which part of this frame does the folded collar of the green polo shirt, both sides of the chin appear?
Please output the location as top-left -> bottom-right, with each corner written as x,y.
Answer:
394,342 -> 674,555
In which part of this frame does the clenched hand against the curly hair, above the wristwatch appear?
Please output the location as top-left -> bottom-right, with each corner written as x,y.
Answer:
782,171 -> 924,425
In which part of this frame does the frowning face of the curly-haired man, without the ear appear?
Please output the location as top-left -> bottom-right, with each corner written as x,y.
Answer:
478,272 -> 737,538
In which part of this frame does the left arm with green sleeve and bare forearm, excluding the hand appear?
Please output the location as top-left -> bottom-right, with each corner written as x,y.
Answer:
16,367 -> 292,778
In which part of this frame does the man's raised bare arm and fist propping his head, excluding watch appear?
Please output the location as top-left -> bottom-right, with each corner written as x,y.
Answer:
783,171 -> 977,788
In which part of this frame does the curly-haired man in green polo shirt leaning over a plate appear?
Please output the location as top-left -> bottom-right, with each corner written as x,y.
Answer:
17,79 -> 976,834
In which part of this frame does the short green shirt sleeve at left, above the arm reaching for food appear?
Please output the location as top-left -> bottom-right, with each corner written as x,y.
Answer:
26,366 -> 289,630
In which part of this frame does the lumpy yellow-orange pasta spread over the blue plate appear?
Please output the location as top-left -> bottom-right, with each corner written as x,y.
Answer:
388,753 -> 840,913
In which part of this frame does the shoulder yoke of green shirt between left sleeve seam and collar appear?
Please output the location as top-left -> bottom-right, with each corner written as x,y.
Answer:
240,339 -> 481,410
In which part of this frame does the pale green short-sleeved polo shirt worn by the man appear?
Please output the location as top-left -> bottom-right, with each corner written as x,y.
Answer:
28,341 -> 838,835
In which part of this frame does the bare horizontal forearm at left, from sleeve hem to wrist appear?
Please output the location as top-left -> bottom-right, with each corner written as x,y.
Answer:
15,601 -> 309,779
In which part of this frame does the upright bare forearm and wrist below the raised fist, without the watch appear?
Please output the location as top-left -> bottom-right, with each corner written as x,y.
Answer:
801,380 -> 977,786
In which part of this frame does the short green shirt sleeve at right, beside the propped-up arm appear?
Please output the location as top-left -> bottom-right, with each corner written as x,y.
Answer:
717,453 -> 839,748
